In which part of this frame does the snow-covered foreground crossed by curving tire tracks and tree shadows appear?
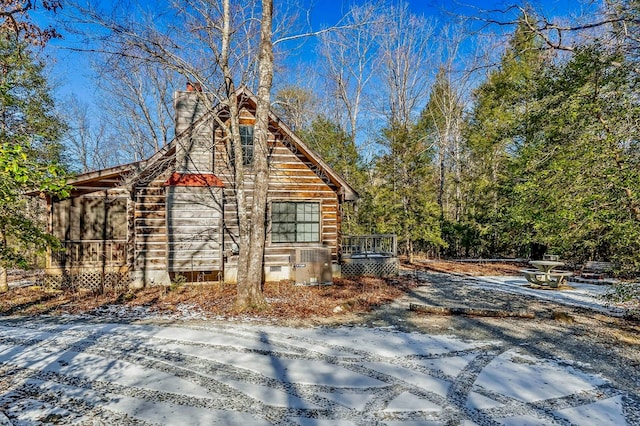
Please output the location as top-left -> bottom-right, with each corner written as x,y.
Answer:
0,314 -> 639,426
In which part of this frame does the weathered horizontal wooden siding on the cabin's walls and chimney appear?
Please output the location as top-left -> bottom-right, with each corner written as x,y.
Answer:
50,93 -> 350,282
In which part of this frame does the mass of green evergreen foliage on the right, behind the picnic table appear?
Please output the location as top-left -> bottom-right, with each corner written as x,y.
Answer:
444,15 -> 640,273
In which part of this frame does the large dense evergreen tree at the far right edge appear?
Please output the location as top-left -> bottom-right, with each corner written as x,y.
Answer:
510,44 -> 640,271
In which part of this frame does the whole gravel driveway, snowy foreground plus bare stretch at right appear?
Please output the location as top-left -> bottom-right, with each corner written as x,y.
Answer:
0,273 -> 640,425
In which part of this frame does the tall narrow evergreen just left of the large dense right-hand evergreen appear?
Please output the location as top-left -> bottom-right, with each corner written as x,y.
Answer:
465,15 -> 544,256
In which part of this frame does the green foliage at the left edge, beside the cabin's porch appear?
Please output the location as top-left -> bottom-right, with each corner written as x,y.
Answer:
0,33 -> 68,267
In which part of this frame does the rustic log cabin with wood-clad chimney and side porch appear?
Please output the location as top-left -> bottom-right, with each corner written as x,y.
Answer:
46,85 -> 358,289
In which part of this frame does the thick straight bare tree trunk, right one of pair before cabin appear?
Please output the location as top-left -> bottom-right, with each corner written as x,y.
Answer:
236,0 -> 273,310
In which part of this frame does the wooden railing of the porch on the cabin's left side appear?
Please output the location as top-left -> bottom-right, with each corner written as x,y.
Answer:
51,240 -> 126,267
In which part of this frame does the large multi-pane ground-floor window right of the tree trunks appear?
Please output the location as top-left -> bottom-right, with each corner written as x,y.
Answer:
271,201 -> 320,243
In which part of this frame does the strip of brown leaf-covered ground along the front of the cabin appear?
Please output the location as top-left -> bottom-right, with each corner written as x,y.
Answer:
0,278 -> 415,321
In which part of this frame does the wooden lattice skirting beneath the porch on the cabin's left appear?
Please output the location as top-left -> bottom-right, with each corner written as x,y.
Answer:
44,271 -> 131,293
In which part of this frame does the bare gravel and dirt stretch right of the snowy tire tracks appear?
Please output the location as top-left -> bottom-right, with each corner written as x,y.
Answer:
361,268 -> 640,397
